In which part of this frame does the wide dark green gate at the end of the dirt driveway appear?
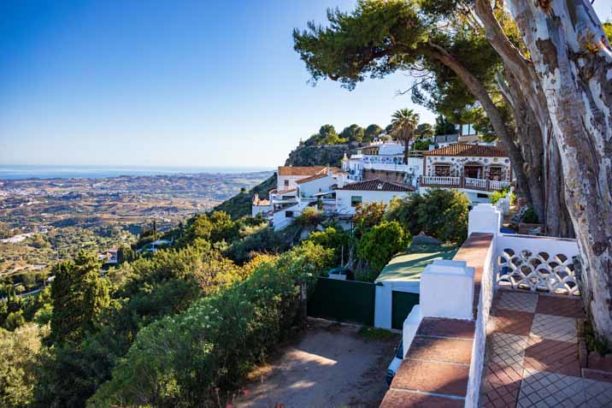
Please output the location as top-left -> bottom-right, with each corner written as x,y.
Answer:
308,278 -> 376,326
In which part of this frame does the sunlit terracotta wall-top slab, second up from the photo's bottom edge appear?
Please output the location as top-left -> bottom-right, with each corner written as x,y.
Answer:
391,359 -> 470,397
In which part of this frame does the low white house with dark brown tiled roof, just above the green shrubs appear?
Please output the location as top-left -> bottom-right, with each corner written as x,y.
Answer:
336,180 -> 414,215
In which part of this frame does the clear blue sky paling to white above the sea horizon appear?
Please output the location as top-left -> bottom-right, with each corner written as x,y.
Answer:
0,0 -> 612,167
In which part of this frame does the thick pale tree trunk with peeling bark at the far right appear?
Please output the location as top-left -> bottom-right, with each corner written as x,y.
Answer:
509,0 -> 612,340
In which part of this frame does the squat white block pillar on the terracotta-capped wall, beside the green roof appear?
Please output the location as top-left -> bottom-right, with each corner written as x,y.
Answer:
420,260 -> 474,320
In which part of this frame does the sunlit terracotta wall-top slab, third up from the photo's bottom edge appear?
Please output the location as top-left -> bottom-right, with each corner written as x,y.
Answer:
406,336 -> 473,365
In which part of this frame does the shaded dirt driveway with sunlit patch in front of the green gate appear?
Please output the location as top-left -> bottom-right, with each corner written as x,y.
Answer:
235,320 -> 399,408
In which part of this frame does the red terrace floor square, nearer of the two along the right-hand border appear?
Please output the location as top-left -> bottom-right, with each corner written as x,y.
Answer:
524,338 -> 581,377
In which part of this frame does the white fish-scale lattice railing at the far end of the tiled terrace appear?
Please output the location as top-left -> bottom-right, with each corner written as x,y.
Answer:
496,234 -> 580,295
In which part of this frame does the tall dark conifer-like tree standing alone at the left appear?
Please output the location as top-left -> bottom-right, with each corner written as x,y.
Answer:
51,252 -> 110,343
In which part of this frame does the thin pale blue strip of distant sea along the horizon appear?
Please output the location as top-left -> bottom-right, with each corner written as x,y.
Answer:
0,165 -> 272,180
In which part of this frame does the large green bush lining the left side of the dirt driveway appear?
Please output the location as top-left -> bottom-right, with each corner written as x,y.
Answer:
89,243 -> 331,407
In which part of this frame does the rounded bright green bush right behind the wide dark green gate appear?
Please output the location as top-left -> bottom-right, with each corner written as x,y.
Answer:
357,221 -> 410,280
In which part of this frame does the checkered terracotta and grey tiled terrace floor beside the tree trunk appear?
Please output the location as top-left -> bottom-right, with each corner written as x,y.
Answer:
481,290 -> 612,407
